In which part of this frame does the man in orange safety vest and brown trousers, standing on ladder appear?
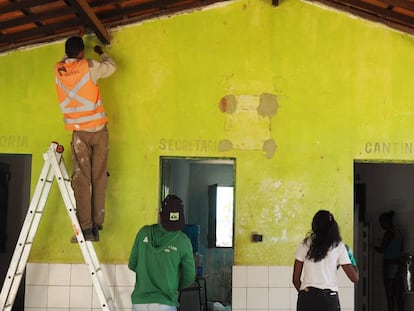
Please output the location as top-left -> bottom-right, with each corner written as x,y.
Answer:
55,36 -> 116,243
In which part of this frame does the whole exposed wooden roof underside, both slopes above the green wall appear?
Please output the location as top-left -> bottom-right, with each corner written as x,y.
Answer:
0,0 -> 414,53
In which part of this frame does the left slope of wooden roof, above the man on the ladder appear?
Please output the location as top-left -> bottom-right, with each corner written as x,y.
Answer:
0,0 -> 226,53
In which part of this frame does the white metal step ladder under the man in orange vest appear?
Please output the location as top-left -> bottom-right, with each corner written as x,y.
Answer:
0,142 -> 116,311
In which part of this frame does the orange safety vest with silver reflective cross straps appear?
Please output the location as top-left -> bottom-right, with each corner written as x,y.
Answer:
55,59 -> 108,131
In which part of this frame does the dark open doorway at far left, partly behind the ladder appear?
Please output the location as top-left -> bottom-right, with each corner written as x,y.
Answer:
0,154 -> 32,310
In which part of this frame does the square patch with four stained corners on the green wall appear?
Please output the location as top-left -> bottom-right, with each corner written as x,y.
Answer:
218,93 -> 279,159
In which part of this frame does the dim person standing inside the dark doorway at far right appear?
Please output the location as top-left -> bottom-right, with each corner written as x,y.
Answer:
375,211 -> 404,311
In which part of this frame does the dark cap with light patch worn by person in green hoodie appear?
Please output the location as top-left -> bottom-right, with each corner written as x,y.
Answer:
160,194 -> 185,231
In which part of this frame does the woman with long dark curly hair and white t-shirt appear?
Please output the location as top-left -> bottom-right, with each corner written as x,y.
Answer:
293,210 -> 359,311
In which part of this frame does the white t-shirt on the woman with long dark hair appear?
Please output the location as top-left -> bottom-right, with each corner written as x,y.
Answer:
295,241 -> 351,291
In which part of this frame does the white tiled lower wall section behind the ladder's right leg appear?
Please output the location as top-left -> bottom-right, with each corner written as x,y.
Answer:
25,263 -> 135,311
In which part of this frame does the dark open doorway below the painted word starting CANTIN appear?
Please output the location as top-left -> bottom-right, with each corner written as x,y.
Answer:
354,162 -> 414,311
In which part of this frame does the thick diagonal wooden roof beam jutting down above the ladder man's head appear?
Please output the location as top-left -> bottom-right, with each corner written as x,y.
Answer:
69,0 -> 111,44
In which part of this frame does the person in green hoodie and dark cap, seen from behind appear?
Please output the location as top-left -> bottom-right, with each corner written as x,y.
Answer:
128,194 -> 195,311
